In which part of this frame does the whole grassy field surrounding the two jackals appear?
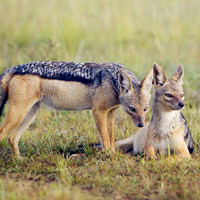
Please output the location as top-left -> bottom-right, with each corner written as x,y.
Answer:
0,0 -> 200,200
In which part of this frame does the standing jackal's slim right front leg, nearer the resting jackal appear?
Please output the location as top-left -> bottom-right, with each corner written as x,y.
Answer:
107,109 -> 116,153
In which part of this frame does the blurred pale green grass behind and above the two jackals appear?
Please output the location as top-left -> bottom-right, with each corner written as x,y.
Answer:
0,0 -> 200,103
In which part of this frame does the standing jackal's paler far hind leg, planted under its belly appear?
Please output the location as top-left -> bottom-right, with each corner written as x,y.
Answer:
9,102 -> 40,157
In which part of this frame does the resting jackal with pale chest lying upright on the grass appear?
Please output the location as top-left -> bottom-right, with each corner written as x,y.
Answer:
116,64 -> 193,158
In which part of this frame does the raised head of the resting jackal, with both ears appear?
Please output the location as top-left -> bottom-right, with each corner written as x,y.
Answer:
153,64 -> 184,111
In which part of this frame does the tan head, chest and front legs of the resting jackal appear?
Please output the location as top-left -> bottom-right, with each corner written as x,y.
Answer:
145,65 -> 190,158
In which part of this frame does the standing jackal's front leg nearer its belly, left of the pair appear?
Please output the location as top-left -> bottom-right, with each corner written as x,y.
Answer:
92,109 -> 110,151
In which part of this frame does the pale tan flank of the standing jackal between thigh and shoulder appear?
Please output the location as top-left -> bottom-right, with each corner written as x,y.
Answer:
41,79 -> 92,110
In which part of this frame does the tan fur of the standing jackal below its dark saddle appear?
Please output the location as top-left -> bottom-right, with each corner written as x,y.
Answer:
0,68 -> 152,156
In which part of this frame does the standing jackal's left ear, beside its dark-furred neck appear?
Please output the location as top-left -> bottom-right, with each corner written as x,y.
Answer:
118,70 -> 132,93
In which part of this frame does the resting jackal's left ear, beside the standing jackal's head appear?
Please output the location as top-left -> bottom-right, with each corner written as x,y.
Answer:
153,63 -> 168,89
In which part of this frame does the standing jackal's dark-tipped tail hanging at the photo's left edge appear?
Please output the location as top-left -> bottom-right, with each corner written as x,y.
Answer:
0,74 -> 11,117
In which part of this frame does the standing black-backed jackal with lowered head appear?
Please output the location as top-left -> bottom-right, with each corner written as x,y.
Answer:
0,61 -> 153,156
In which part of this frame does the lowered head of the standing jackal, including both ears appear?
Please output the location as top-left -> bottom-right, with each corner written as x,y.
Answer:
119,70 -> 153,127
